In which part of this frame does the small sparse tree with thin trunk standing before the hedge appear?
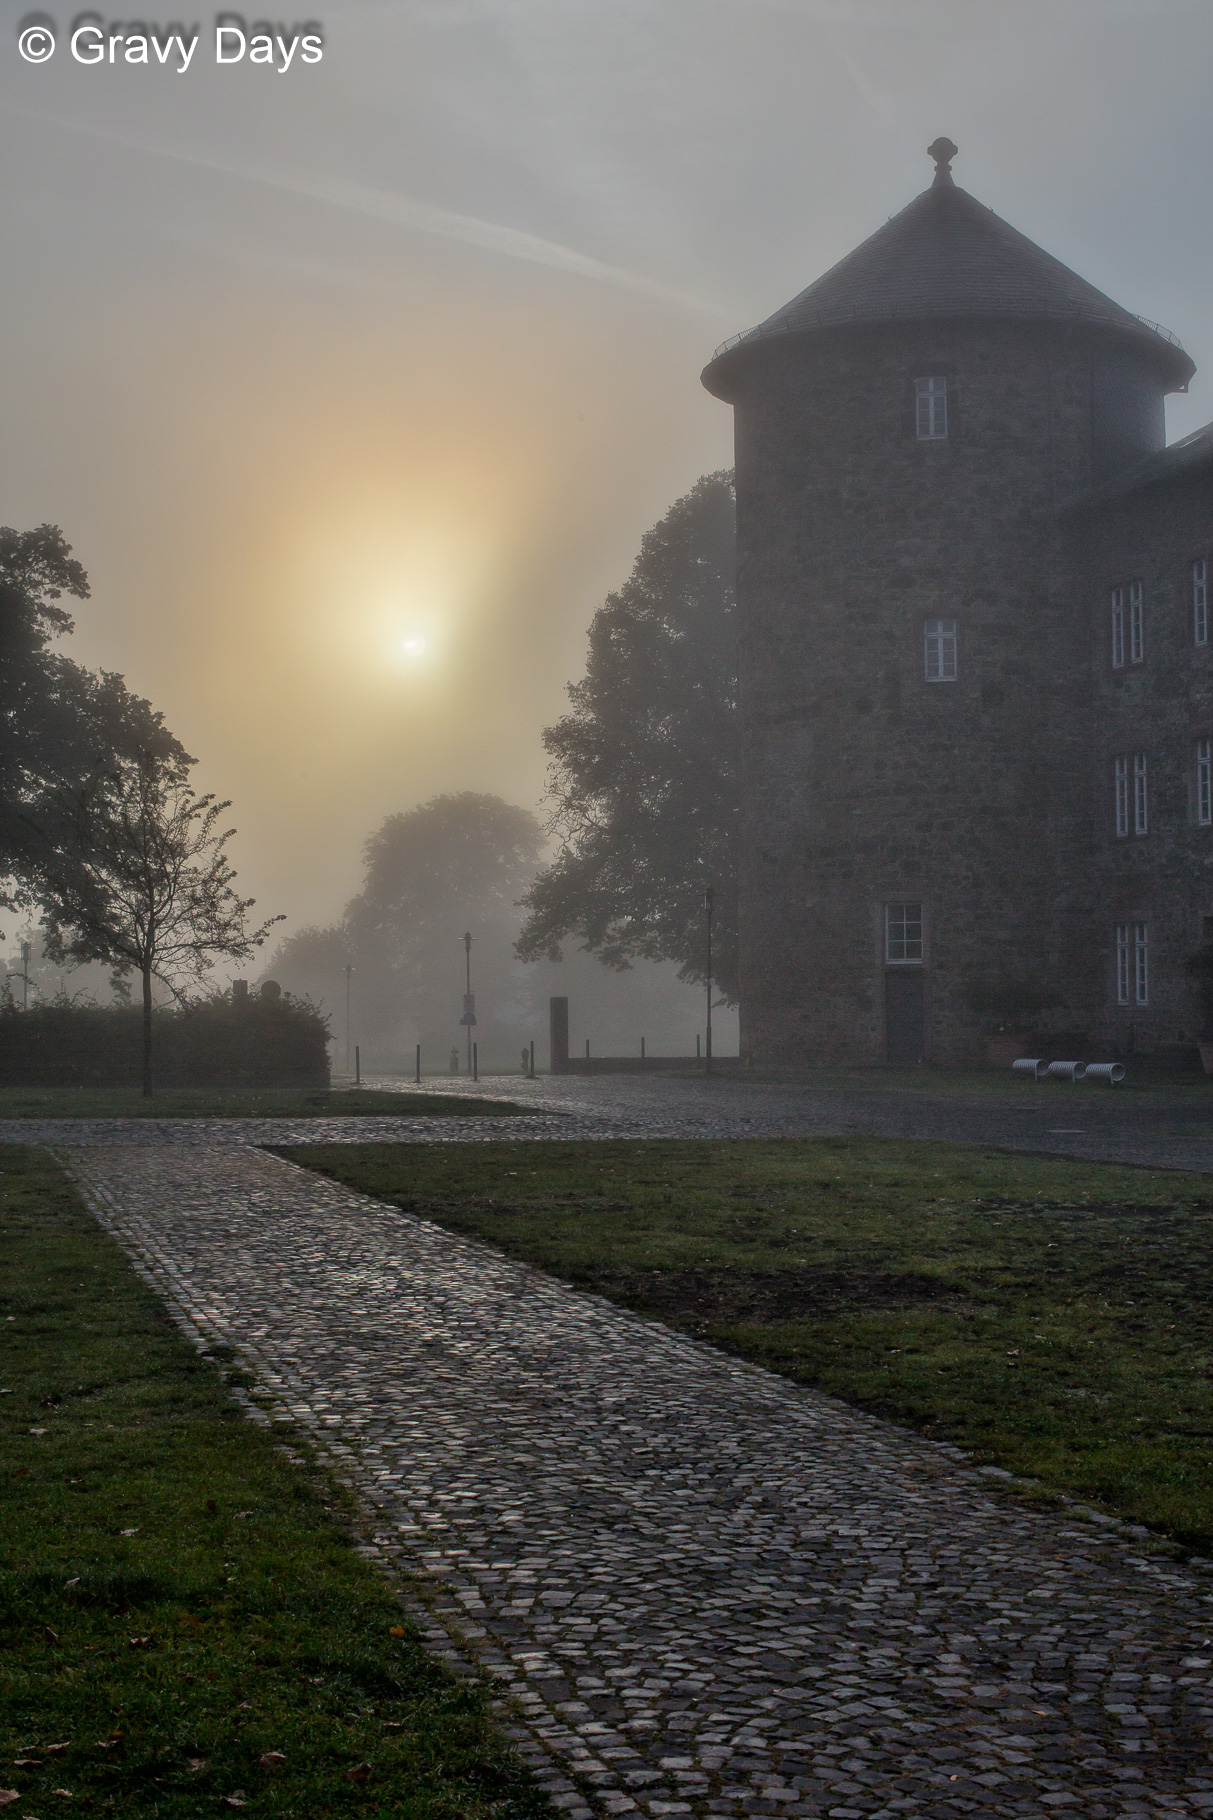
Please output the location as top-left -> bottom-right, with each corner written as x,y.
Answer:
33,752 -> 282,1096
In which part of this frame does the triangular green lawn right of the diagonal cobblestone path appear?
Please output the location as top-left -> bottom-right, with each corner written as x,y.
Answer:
290,1138 -> 1213,1552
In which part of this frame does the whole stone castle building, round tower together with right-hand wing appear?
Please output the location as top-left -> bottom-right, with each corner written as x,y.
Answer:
703,140 -> 1213,1063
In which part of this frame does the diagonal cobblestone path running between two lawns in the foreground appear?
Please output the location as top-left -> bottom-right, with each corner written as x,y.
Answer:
60,1127 -> 1213,1820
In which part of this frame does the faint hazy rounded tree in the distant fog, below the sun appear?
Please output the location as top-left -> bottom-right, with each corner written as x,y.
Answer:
268,790 -> 543,1063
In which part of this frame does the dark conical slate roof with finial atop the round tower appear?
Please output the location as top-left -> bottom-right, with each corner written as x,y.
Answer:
703,140 -> 1195,397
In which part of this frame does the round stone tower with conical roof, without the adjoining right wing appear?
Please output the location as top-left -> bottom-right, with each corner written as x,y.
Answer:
703,140 -> 1193,1063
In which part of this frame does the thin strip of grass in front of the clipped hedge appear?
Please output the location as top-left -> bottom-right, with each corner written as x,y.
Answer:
0,1087 -> 528,1119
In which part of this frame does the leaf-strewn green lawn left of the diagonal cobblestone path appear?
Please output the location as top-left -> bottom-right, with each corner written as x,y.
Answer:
0,1147 -> 550,1820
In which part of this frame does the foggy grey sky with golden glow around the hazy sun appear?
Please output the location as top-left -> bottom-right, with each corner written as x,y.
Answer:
0,0 -> 1213,928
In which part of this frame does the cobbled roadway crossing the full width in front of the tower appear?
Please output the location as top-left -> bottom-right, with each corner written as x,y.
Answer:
0,1074 -> 1213,1172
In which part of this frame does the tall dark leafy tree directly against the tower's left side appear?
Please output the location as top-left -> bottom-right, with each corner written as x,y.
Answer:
517,473 -> 738,1003
